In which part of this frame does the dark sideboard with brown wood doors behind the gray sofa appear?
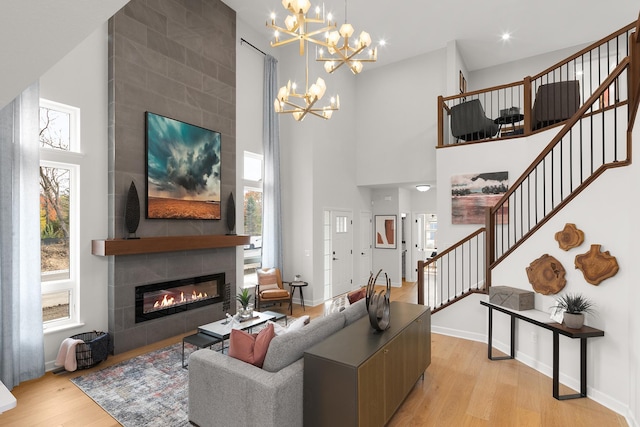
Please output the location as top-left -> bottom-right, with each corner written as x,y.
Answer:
303,301 -> 431,427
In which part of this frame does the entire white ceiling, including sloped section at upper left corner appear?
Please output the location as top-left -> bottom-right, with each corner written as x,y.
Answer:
0,0 -> 639,108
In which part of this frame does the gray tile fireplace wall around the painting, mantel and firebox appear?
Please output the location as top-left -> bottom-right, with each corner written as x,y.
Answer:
107,0 -> 238,353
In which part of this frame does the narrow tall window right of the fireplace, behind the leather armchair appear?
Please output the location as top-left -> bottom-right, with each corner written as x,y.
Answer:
243,151 -> 262,283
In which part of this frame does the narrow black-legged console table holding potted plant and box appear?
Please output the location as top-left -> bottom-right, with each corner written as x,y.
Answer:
480,301 -> 604,400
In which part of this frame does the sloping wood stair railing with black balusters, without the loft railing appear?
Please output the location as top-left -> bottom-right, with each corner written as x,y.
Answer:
417,15 -> 640,312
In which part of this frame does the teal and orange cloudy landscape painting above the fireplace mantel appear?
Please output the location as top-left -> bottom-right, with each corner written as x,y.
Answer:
145,112 -> 221,219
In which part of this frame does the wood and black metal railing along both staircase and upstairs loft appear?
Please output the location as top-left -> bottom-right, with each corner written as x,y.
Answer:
417,17 -> 640,313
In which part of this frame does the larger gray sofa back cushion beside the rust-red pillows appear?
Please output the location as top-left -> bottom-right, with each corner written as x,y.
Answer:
262,313 -> 344,372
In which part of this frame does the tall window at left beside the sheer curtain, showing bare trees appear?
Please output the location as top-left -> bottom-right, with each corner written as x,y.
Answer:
39,100 -> 80,329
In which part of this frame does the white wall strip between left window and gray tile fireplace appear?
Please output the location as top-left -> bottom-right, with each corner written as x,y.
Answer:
40,23 -> 108,369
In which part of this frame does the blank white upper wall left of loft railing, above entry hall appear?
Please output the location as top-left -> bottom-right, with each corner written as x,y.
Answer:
356,49 -> 446,186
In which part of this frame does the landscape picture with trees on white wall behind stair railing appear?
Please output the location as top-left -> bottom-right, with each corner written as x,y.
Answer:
451,172 -> 509,224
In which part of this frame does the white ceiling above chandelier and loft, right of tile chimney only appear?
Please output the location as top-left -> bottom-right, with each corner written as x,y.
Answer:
222,0 -> 640,71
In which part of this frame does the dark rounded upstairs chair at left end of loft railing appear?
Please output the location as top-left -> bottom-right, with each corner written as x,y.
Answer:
451,99 -> 499,141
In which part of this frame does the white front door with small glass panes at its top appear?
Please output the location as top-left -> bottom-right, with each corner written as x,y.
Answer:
331,211 -> 353,297
